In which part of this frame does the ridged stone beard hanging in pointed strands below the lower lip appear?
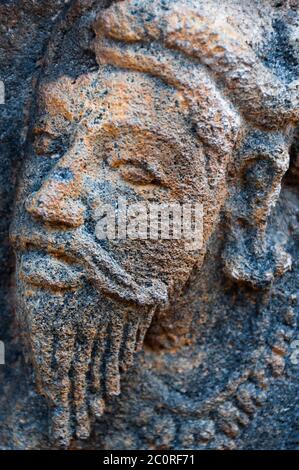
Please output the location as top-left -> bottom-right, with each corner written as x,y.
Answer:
17,255 -> 155,447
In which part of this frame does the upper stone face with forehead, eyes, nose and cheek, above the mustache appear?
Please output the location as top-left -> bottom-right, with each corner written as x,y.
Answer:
13,67 -> 234,298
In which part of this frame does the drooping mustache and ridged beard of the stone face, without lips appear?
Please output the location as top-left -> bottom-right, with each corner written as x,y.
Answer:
11,226 -> 167,448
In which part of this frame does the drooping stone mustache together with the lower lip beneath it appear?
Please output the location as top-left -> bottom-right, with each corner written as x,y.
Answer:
10,226 -> 168,306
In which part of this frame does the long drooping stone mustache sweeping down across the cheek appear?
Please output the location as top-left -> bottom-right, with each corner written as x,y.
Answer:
10,227 -> 168,306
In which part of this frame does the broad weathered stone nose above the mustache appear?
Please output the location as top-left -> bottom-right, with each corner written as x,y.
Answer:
25,166 -> 85,228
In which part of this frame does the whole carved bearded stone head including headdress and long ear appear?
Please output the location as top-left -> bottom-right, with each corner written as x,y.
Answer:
1,0 -> 299,448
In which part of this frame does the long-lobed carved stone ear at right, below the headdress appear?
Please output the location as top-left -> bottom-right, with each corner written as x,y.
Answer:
223,131 -> 291,288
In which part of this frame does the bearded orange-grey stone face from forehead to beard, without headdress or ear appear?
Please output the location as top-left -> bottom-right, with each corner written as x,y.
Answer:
10,69 -> 238,444
